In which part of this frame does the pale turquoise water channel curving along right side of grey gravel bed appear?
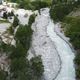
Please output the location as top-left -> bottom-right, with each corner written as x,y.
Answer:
47,21 -> 75,80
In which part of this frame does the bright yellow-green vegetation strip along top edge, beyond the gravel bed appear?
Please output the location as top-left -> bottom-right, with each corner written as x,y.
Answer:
16,0 -> 50,10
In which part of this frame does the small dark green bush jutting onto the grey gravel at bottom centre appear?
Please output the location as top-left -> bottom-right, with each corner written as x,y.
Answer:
30,56 -> 44,78
